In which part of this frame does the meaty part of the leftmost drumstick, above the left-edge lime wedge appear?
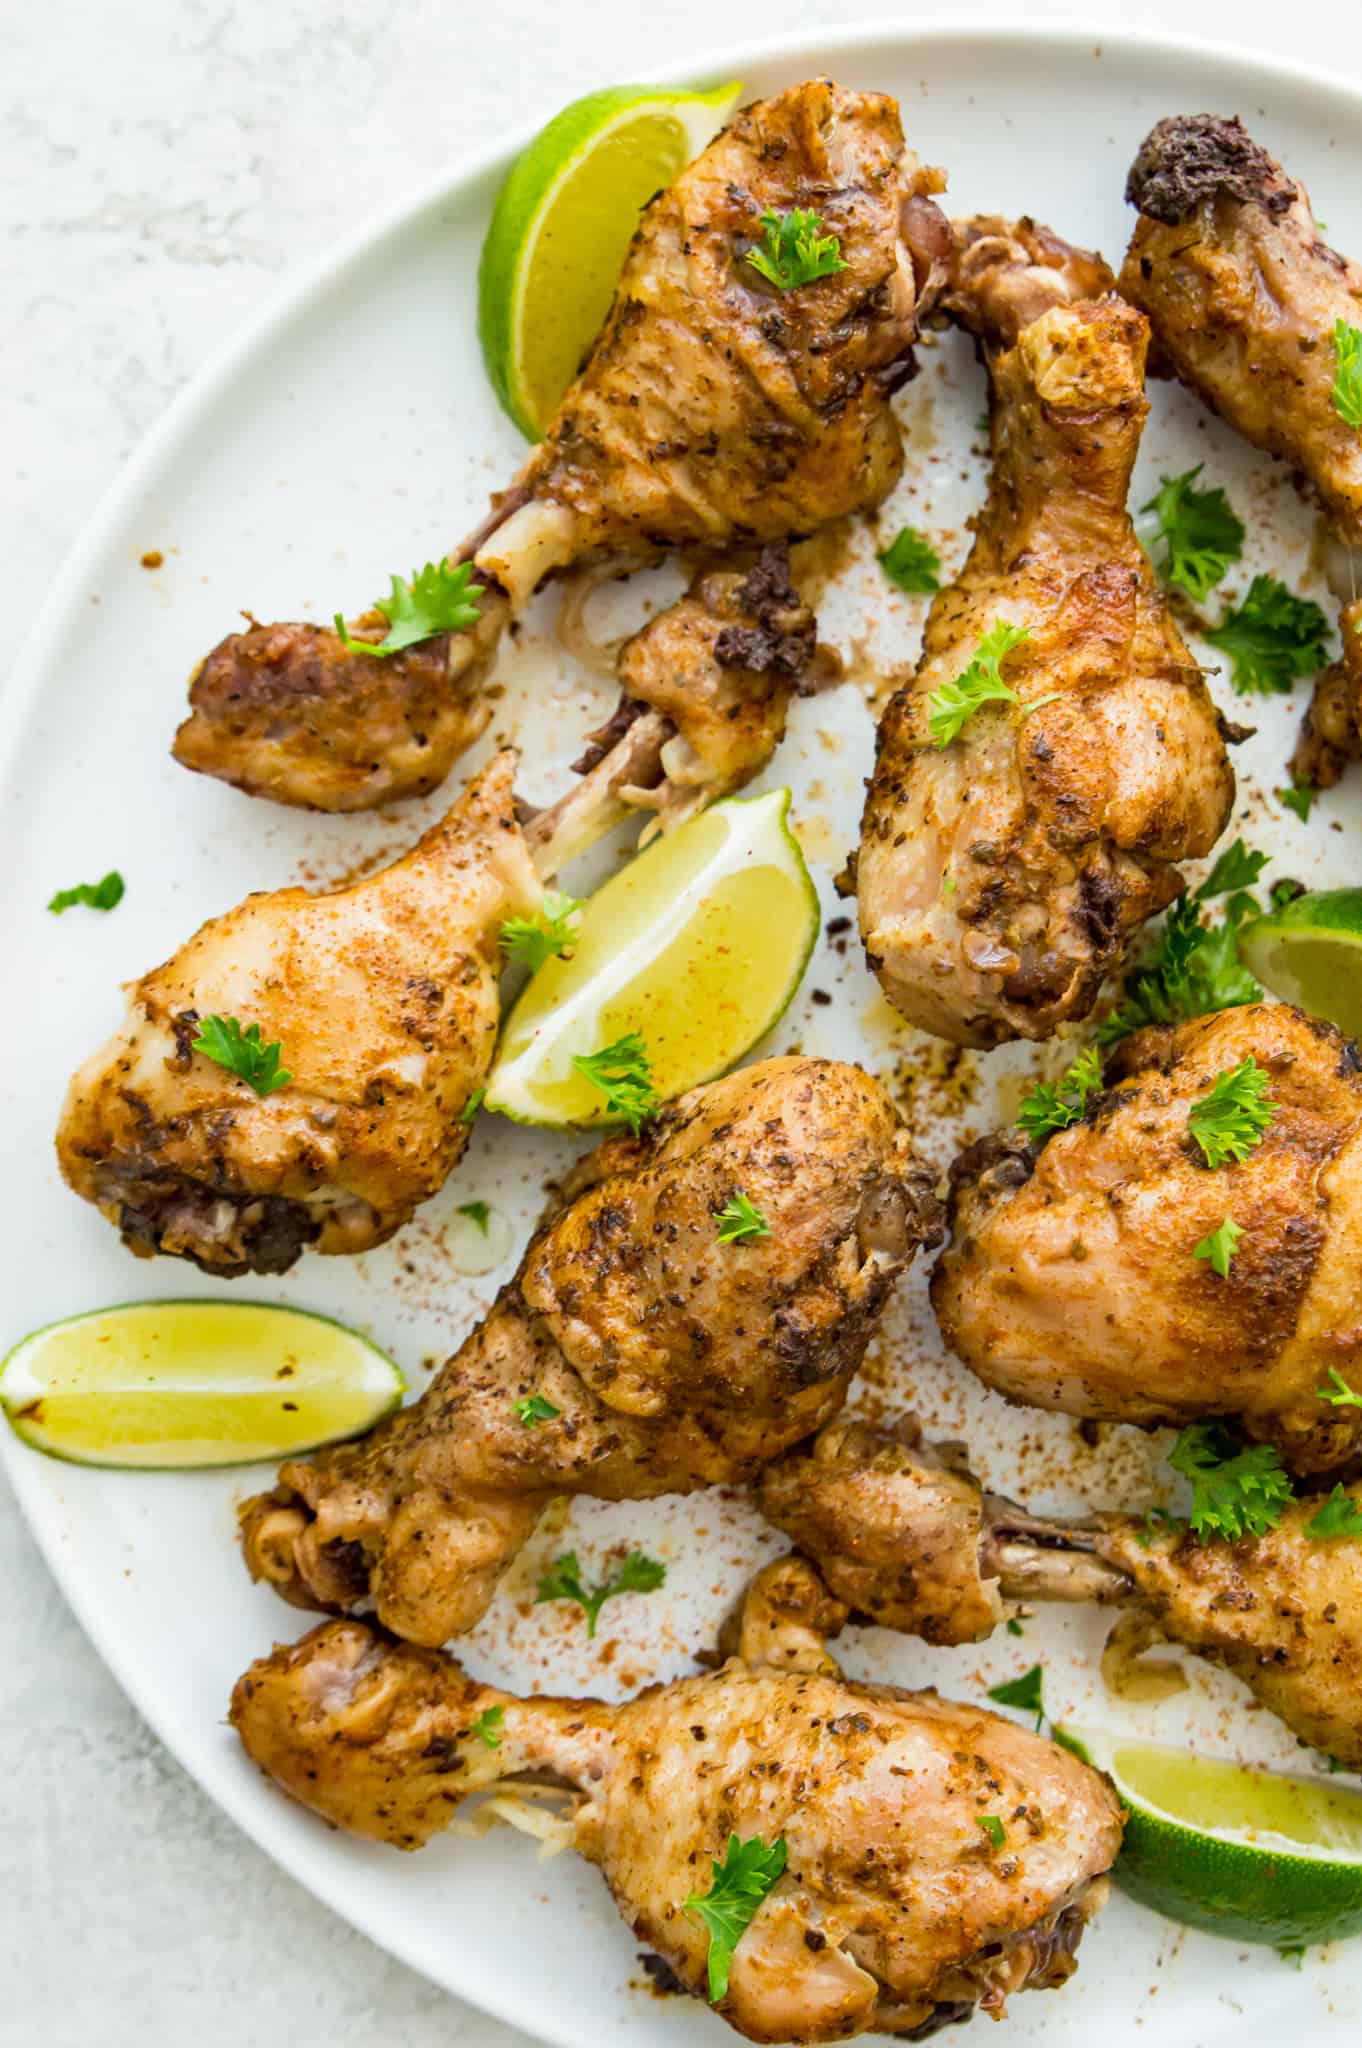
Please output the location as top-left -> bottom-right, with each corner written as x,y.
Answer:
57,754 -> 539,1278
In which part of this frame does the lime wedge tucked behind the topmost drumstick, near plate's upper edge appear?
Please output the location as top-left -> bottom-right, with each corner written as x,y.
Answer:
477,84 -> 739,440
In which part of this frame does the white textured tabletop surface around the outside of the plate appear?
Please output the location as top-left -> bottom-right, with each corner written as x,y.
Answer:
0,0 -> 1362,2048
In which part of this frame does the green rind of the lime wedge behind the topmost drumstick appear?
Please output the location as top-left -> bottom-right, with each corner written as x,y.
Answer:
477,84 -> 739,440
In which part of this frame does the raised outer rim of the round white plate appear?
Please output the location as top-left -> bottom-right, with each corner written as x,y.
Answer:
10,12 -> 1362,2048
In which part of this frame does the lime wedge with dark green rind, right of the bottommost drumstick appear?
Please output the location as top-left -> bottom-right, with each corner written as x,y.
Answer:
1057,1729 -> 1362,1948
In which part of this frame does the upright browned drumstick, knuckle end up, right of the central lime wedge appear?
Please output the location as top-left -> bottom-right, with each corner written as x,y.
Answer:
856,229 -> 1235,1047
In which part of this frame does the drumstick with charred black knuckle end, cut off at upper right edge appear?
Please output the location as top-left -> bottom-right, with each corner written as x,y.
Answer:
1120,115 -> 1362,788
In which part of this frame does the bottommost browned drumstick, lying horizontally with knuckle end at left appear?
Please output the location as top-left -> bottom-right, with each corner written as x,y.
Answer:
231,1571 -> 1120,2042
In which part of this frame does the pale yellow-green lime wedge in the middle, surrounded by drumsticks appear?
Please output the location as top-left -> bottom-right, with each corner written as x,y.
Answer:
487,788 -> 819,1128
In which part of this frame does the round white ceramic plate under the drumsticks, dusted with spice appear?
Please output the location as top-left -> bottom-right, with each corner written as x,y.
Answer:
0,29 -> 1362,2048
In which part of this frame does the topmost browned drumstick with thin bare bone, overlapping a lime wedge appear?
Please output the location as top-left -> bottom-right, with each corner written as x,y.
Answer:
174,80 -> 950,811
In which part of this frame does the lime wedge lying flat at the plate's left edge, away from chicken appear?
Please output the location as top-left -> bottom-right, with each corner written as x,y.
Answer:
0,1300 -> 403,1470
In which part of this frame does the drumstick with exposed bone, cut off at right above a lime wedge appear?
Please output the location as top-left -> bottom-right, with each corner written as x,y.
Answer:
758,1417 -> 1362,1767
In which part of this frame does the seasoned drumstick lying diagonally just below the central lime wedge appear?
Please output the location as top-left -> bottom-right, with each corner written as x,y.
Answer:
242,1059 -> 938,1645
